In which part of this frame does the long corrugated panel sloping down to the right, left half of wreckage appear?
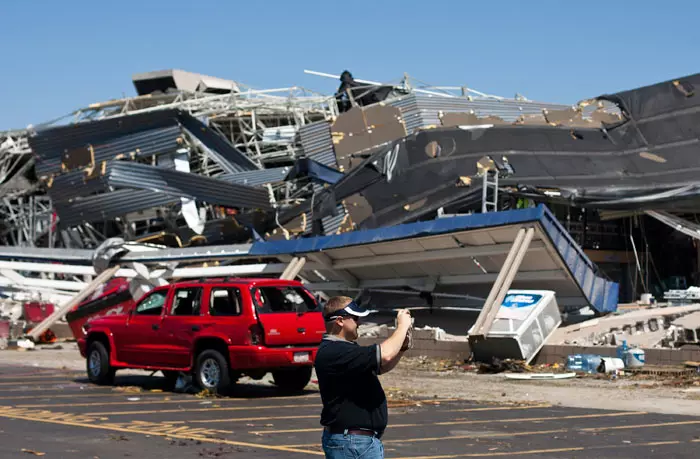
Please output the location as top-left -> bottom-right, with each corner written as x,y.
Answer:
107,161 -> 272,209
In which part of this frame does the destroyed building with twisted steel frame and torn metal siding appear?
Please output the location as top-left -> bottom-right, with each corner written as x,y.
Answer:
0,70 -> 700,328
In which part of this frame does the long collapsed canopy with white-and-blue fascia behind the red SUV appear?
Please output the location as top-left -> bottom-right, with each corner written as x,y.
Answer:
0,205 -> 619,313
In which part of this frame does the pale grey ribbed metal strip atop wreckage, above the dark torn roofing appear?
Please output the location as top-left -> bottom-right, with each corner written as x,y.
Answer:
387,93 -> 570,134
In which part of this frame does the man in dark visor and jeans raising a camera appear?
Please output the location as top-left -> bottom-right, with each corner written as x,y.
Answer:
314,296 -> 411,459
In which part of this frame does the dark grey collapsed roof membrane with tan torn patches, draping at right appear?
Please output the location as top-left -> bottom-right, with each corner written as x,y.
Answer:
281,74 -> 700,234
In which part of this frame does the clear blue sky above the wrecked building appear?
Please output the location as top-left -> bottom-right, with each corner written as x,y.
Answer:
0,0 -> 700,130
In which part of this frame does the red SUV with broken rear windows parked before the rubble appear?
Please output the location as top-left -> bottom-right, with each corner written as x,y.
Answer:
78,279 -> 325,391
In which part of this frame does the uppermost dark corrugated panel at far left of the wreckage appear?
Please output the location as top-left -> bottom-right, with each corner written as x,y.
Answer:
29,110 -> 181,176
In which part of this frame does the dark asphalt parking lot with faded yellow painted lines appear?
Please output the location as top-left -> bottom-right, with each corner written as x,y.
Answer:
0,367 -> 700,459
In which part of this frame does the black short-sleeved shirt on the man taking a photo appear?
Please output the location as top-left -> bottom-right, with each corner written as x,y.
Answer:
314,335 -> 388,434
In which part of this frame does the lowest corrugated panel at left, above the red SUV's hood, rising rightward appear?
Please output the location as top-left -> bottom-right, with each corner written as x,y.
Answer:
55,190 -> 180,228
